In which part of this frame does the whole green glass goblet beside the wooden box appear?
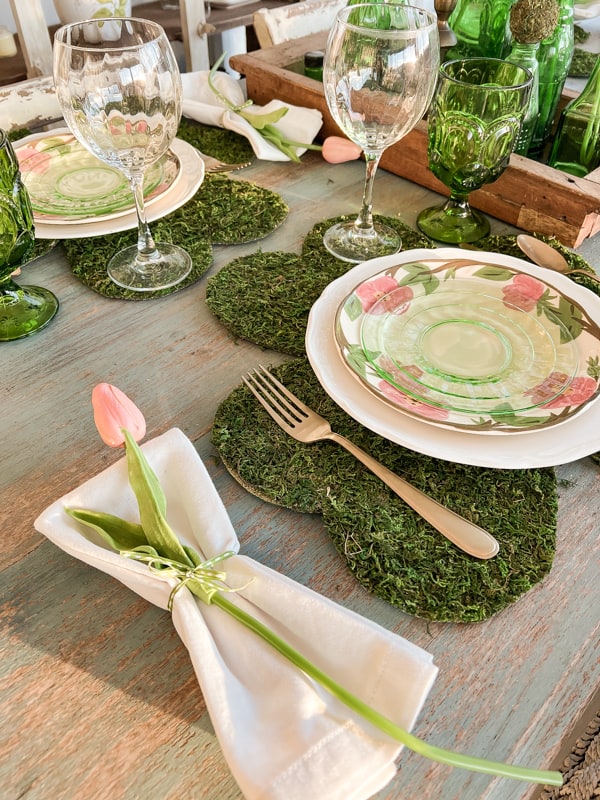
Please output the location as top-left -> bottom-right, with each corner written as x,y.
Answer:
417,58 -> 532,244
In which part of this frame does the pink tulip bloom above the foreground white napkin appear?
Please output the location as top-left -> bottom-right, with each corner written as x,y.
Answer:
92,383 -> 146,447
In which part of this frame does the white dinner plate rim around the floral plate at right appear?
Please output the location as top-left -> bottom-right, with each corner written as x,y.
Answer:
306,248 -> 600,469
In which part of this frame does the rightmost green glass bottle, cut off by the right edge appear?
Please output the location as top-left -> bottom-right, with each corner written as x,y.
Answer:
548,58 -> 600,178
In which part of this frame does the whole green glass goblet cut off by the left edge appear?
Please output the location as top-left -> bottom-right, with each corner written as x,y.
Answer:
0,130 -> 58,342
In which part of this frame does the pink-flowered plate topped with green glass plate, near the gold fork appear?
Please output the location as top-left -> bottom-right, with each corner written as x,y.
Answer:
335,256 -> 600,432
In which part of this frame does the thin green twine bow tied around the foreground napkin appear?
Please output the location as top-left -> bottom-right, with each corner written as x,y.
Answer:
119,545 -> 241,611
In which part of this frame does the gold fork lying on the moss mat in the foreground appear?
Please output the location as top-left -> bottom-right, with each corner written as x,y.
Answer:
242,366 -> 499,559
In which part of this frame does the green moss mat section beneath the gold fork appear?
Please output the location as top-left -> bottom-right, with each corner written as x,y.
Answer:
212,358 -> 557,622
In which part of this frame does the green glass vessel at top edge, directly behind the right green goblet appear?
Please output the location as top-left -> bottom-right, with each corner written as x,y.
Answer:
447,0 -> 515,59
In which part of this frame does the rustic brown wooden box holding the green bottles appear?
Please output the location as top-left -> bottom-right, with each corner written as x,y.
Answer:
230,33 -> 600,247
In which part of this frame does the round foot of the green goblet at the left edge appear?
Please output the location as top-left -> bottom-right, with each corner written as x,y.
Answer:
0,278 -> 58,342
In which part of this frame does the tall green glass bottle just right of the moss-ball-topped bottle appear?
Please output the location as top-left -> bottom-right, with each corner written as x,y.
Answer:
529,0 -> 575,158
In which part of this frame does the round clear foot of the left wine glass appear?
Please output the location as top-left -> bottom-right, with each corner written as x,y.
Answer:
107,242 -> 193,292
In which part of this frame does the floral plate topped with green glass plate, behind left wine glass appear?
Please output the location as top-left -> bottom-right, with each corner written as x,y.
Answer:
15,130 -> 181,224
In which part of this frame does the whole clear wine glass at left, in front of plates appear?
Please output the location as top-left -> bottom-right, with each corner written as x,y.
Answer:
54,17 -> 192,292
